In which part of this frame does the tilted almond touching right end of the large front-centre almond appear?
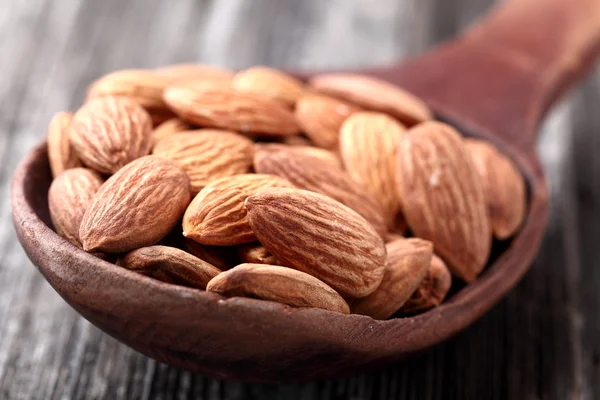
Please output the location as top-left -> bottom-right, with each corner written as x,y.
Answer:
352,239 -> 433,319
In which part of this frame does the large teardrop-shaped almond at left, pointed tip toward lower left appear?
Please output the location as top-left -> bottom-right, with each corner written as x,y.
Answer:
79,156 -> 190,253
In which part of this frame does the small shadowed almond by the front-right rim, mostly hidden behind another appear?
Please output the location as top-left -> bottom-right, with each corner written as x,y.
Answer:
400,254 -> 452,314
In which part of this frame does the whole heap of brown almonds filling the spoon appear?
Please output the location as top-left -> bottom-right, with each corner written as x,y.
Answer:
48,64 -> 526,319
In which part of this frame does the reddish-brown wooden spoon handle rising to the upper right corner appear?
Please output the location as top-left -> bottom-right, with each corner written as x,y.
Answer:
378,0 -> 600,150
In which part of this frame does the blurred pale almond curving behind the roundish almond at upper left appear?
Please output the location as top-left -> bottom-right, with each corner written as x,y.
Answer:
87,69 -> 173,123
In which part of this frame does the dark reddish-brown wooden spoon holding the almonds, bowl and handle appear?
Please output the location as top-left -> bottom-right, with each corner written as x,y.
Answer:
12,0 -> 600,382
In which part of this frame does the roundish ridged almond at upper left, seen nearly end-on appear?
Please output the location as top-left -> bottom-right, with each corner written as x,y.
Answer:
69,96 -> 152,174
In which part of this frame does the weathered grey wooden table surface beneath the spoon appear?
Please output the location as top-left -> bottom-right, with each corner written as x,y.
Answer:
0,0 -> 600,399
